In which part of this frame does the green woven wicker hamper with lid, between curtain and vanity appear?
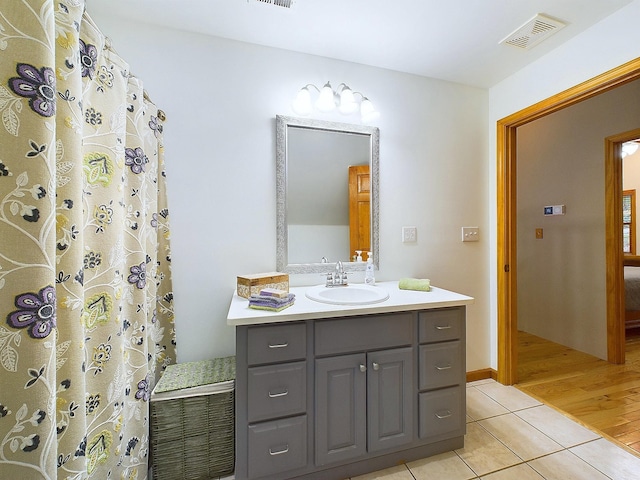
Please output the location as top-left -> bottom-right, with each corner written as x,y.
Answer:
150,357 -> 236,480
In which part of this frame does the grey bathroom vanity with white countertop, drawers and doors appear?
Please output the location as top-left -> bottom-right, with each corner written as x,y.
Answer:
227,282 -> 473,480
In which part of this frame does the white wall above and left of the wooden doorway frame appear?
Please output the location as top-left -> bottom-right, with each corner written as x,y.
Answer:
488,0 -> 640,368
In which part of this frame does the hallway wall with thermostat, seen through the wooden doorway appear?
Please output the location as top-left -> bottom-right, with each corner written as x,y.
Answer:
517,81 -> 640,359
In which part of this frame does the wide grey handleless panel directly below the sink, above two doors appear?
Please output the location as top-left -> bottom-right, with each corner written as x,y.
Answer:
315,312 -> 413,355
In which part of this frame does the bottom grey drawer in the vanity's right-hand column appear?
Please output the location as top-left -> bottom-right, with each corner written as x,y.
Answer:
419,387 -> 466,440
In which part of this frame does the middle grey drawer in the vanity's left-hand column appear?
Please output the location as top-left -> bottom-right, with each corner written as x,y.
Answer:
247,362 -> 307,422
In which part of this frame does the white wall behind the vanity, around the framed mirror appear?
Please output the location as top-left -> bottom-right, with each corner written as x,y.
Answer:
89,10 -> 494,371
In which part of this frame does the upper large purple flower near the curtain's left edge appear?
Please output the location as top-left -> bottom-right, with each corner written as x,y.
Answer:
9,63 -> 56,117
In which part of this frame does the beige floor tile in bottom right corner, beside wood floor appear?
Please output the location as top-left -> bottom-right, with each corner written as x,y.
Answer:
570,438 -> 640,480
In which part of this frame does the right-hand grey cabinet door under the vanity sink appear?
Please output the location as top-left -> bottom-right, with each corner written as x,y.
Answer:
367,347 -> 414,452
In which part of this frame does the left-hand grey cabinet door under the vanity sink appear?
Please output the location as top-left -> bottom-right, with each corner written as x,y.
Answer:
316,353 -> 367,465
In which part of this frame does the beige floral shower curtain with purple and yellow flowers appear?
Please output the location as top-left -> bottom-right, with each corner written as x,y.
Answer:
0,0 -> 176,480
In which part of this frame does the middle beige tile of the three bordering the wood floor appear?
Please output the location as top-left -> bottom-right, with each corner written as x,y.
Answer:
515,405 -> 600,448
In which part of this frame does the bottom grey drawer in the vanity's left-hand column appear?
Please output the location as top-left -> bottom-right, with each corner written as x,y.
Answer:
248,415 -> 307,478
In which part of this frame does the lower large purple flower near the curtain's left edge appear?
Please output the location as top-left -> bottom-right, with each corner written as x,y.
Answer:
7,285 -> 56,339
